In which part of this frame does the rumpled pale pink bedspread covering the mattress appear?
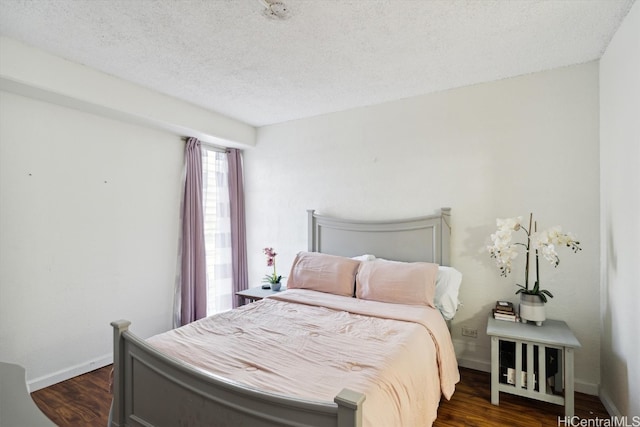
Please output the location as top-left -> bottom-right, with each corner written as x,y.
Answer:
149,289 -> 459,427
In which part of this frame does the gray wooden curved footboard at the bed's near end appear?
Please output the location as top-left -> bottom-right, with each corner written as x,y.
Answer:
110,320 -> 365,427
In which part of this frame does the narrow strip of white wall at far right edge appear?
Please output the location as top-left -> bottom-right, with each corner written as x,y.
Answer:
600,3 -> 640,417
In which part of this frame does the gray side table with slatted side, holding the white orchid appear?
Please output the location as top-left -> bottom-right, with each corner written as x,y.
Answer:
487,317 -> 580,417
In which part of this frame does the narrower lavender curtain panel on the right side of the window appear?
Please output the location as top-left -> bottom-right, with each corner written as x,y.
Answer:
227,148 -> 249,308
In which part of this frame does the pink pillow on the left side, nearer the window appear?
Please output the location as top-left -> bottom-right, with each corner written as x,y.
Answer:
287,252 -> 360,297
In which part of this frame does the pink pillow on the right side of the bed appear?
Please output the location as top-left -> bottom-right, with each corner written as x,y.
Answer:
356,259 -> 438,308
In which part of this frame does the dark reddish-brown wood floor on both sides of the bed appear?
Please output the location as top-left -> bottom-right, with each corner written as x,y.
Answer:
31,366 -> 609,427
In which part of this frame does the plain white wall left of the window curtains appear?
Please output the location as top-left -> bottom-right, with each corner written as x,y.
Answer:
0,92 -> 184,390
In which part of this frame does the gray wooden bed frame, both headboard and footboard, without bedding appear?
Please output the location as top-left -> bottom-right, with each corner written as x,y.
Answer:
110,208 -> 450,427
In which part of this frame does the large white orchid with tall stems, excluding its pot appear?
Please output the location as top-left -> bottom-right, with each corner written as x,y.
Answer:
487,214 -> 582,302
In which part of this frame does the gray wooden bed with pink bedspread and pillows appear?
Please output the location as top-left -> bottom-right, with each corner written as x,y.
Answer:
111,208 -> 459,427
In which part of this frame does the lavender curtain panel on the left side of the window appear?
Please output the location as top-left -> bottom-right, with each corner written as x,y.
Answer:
180,138 -> 207,325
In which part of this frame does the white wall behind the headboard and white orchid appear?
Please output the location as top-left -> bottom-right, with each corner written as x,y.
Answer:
245,62 -> 600,394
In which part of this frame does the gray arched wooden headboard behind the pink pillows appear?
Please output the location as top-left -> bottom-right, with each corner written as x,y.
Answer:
307,208 -> 451,266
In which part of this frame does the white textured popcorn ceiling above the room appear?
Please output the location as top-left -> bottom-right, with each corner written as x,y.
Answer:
0,0 -> 634,126
